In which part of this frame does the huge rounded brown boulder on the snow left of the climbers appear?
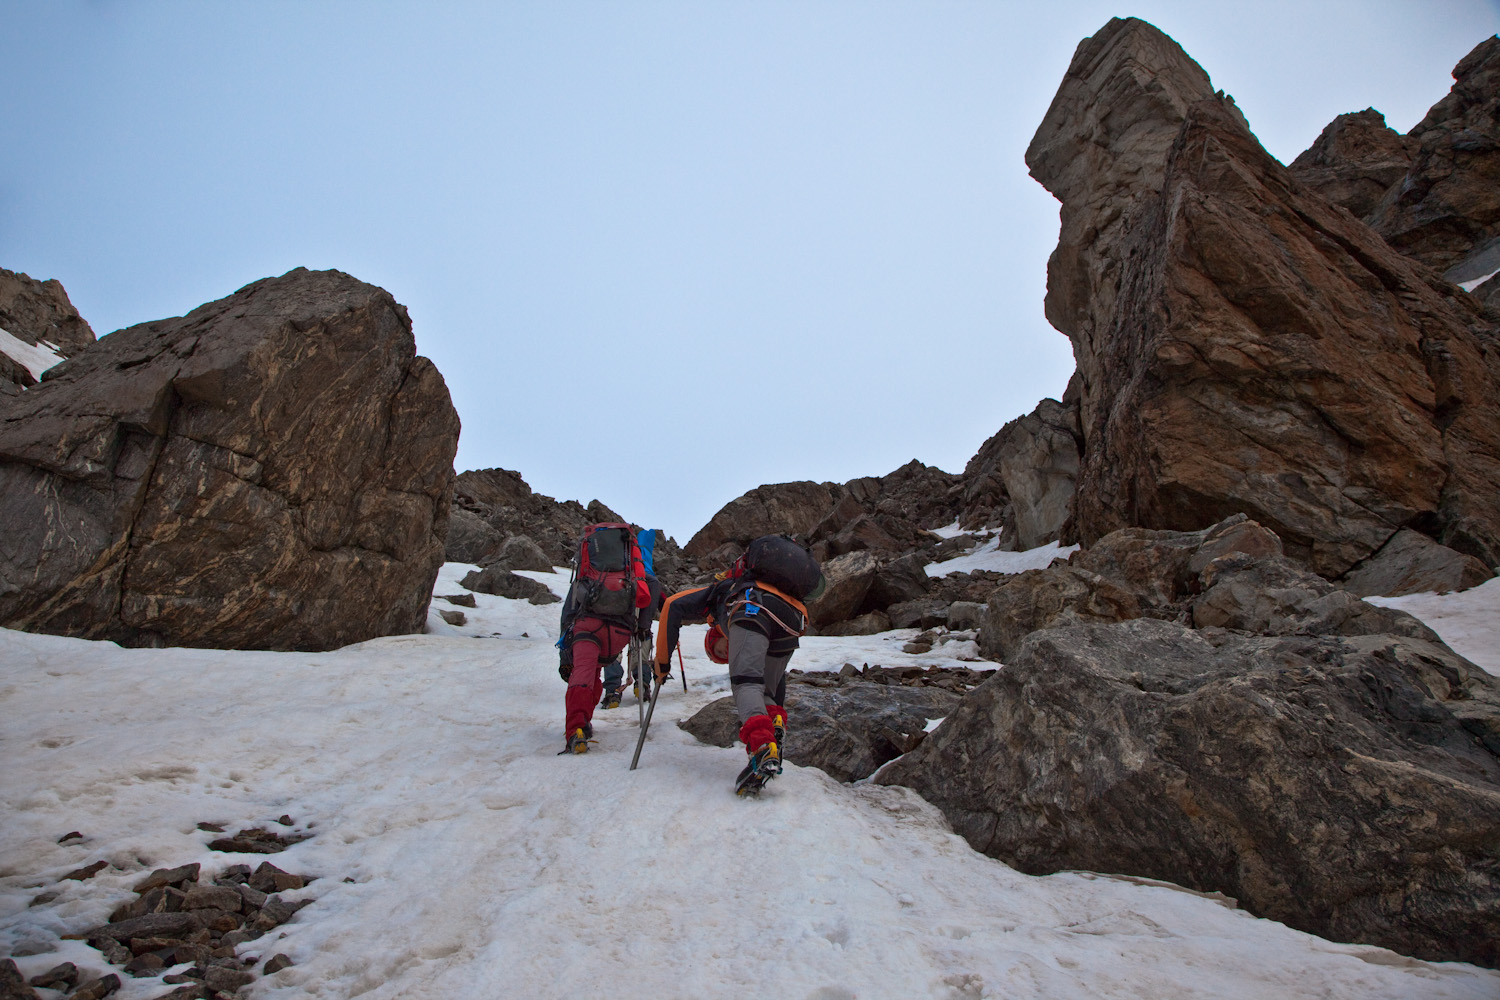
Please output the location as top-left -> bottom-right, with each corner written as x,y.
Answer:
0,268 -> 459,649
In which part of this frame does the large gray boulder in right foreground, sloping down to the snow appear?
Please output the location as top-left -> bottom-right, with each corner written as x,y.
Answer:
876,619 -> 1500,966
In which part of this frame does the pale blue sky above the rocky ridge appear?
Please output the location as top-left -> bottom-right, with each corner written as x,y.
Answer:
0,0 -> 1500,541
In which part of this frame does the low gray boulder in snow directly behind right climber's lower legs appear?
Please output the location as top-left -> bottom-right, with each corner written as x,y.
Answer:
678,681 -> 960,781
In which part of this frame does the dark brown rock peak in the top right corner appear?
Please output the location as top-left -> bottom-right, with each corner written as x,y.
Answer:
1370,37 -> 1500,270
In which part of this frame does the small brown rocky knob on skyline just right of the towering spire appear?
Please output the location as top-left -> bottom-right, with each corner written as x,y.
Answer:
1287,108 -> 1419,219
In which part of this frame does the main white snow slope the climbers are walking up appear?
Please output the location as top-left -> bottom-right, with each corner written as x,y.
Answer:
0,565 -> 1500,1000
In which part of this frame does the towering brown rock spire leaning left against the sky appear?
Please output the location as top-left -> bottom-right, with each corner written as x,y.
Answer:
1028,19 -> 1500,577
